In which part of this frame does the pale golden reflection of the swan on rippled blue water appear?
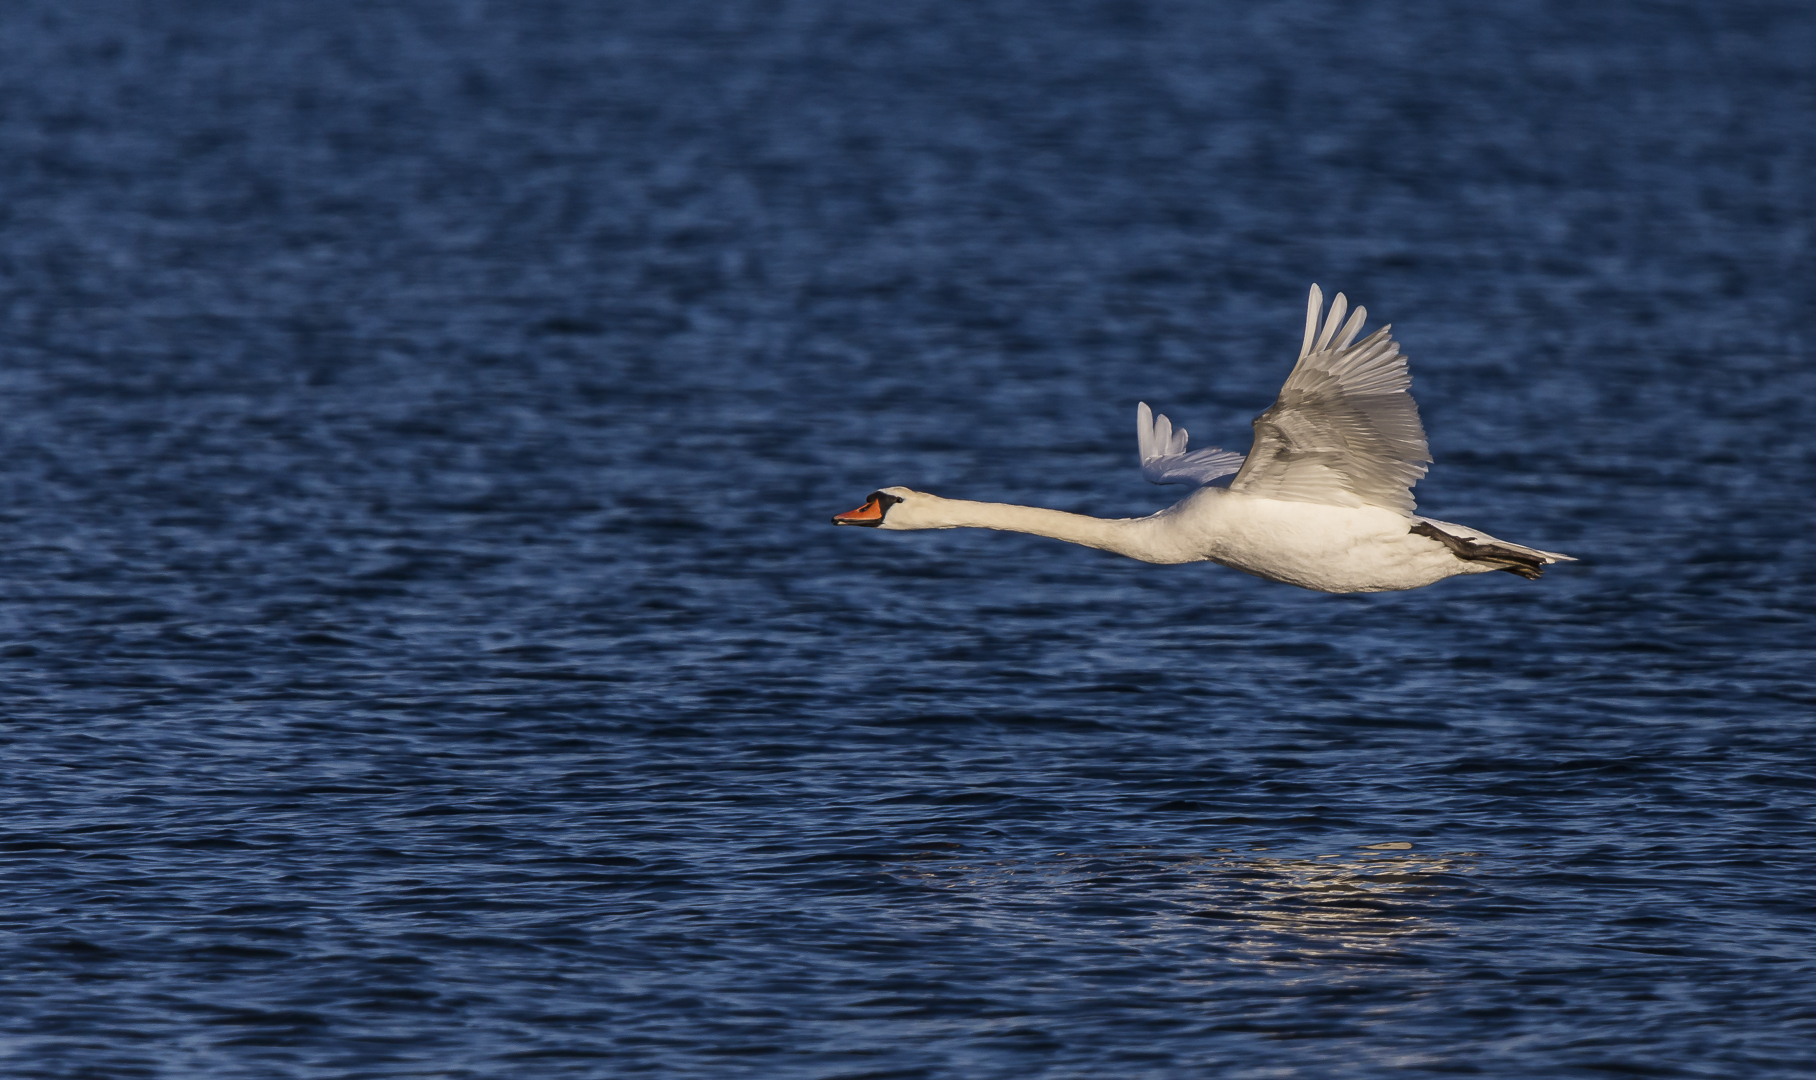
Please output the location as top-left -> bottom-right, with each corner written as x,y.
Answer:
892,842 -> 1482,964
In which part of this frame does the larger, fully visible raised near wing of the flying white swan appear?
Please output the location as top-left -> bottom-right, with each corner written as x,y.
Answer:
1229,285 -> 1431,514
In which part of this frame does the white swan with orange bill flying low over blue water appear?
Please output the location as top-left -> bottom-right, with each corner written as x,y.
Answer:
832,285 -> 1574,594
